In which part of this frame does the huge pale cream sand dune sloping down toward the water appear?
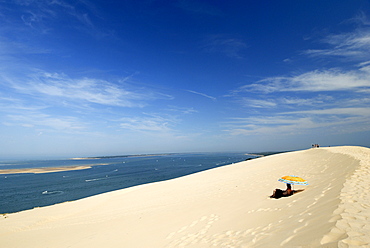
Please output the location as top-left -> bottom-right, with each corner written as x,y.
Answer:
0,147 -> 370,248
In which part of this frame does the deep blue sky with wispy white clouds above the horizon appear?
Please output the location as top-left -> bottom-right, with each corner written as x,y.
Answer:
0,0 -> 370,158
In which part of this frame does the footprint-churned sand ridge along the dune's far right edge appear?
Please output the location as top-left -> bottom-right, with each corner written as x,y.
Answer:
321,147 -> 370,247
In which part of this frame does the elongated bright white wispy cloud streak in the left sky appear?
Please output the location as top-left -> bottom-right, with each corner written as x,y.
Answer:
7,72 -> 163,107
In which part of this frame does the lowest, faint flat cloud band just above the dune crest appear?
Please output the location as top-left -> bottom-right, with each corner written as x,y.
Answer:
225,108 -> 370,135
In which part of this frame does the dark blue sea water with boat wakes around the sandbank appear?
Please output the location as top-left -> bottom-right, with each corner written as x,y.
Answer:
0,153 -> 253,213
